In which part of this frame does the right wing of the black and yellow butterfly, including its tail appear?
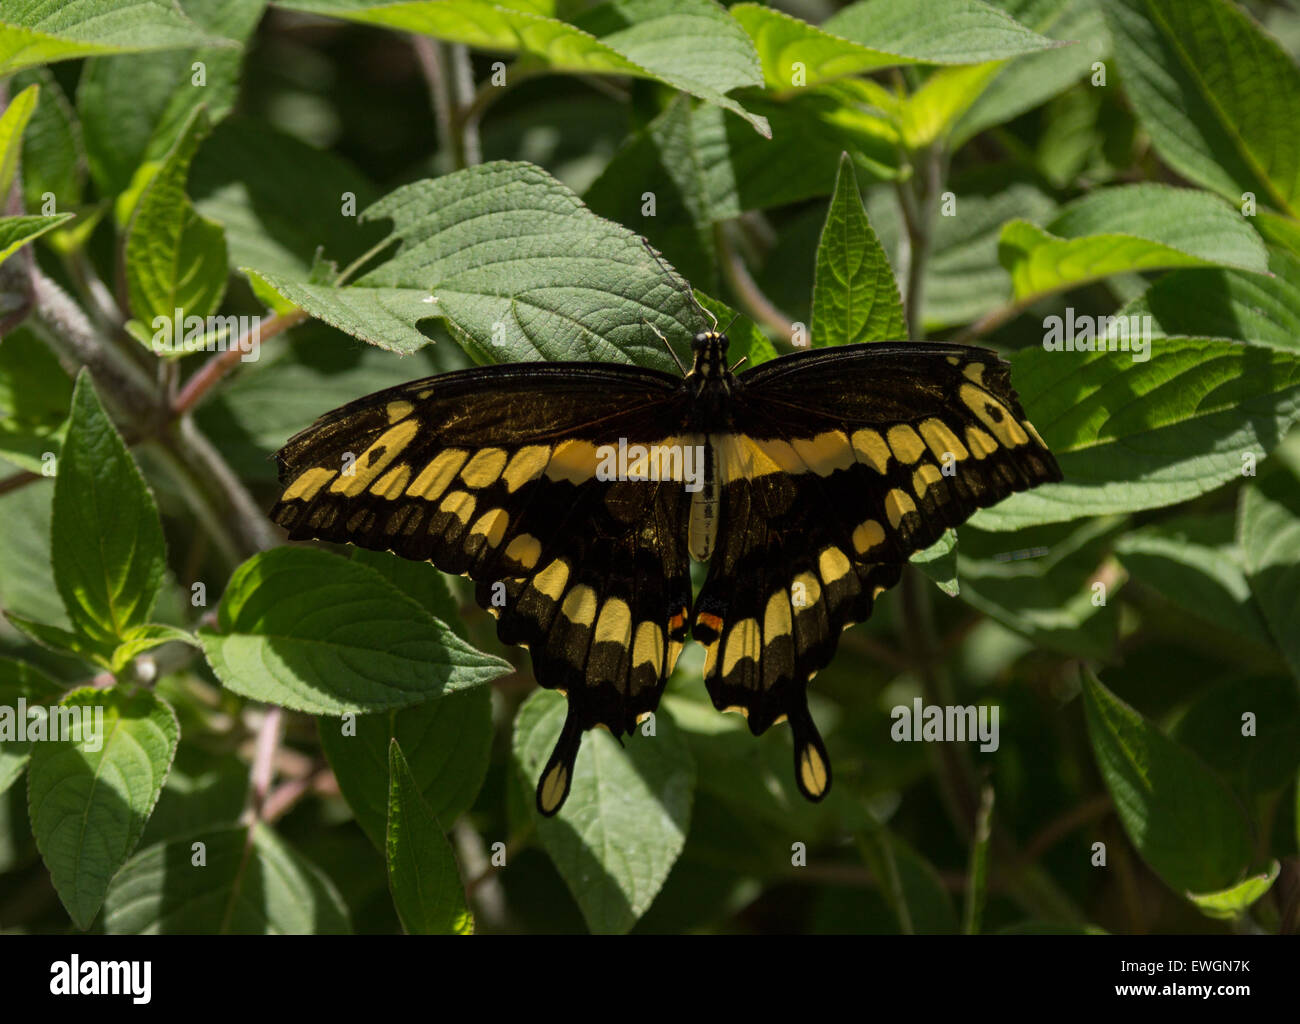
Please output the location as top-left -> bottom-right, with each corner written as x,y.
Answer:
693,343 -> 1061,800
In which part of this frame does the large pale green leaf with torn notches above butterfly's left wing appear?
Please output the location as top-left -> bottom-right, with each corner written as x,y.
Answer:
246,162 -> 722,370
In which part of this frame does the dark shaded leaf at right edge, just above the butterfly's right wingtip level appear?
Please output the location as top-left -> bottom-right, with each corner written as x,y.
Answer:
1117,247 -> 1300,352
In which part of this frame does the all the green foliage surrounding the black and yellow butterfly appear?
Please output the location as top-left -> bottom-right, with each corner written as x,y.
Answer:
0,0 -> 1300,934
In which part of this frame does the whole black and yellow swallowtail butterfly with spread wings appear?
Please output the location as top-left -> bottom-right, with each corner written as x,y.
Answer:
270,324 -> 1061,815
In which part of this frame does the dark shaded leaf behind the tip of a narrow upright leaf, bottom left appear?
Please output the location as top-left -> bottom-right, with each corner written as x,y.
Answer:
317,686 -> 493,850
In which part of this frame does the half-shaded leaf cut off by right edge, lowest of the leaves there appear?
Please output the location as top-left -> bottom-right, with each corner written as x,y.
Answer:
1238,470 -> 1300,678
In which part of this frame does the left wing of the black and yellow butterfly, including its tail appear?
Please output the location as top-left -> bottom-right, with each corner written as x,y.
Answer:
270,364 -> 690,813
